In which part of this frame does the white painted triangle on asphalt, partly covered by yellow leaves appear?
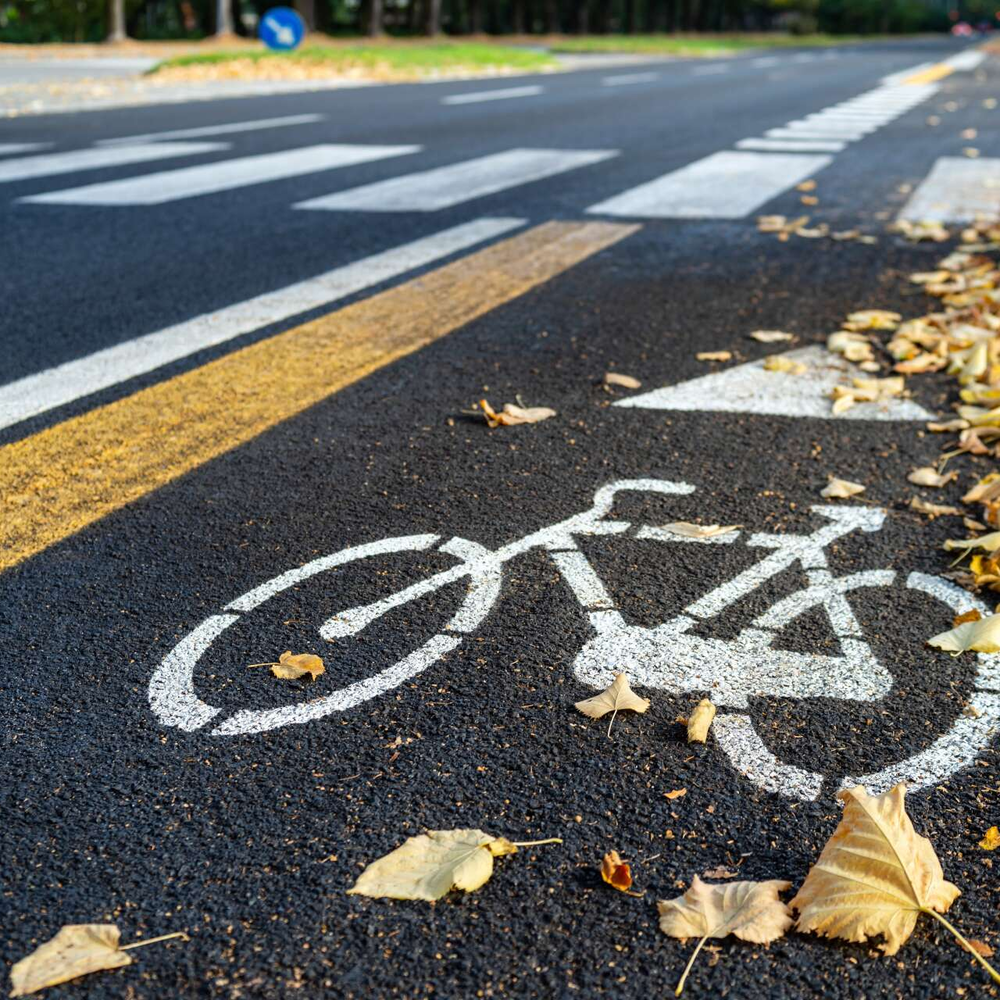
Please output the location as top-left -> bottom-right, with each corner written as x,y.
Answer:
614,345 -> 934,420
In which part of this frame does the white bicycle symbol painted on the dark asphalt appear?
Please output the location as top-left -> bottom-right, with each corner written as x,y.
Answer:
149,479 -> 1000,800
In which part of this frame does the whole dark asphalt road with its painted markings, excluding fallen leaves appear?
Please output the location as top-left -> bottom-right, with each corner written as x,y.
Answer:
0,40 -> 1000,1000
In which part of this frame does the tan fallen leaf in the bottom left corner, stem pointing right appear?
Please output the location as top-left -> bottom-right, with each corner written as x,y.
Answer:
10,924 -> 188,997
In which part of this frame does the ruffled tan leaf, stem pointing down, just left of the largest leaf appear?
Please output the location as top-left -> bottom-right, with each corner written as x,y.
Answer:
656,875 -> 792,996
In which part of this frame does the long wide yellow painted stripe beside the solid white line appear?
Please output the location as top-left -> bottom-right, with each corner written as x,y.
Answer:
0,222 -> 640,570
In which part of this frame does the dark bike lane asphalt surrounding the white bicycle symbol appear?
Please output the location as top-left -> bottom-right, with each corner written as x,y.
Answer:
0,111 -> 1000,997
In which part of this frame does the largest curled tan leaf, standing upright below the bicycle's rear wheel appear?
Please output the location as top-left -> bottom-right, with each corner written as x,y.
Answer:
791,783 -> 1000,982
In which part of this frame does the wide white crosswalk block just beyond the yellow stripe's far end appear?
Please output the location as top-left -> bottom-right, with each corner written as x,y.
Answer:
587,150 -> 833,219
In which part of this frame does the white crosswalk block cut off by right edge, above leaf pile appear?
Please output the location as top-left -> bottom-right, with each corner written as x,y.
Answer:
899,156 -> 1000,222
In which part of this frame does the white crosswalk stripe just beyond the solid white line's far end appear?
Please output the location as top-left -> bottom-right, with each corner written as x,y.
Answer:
294,149 -> 618,212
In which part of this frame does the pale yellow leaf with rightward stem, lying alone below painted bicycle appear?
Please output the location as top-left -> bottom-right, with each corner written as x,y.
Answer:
347,830 -> 562,902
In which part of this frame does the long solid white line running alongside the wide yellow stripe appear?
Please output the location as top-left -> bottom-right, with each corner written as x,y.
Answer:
0,218 -> 524,428
